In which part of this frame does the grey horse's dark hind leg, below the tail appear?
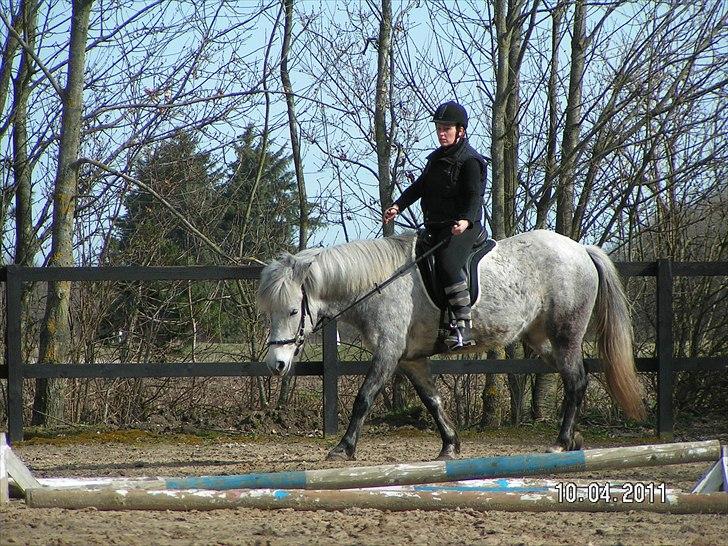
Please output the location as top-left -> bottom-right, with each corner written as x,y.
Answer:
551,341 -> 588,451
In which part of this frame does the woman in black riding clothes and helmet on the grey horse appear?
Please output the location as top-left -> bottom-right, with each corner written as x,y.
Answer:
384,101 -> 487,349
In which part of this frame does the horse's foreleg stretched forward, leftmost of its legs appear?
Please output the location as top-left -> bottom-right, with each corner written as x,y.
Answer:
326,351 -> 398,460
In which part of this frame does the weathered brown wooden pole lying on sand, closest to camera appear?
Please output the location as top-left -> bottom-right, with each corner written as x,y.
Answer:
26,488 -> 728,514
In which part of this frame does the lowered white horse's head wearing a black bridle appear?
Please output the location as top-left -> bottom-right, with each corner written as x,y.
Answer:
258,250 -> 317,375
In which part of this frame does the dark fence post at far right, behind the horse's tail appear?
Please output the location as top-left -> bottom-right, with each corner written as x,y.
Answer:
657,259 -> 674,440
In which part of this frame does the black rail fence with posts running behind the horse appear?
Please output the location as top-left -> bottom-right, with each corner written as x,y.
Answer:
0,260 -> 728,441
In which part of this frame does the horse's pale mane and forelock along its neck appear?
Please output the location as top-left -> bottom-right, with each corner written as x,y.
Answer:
258,235 -> 414,311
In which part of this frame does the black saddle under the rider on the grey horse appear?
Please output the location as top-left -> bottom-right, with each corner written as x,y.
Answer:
415,229 -> 496,311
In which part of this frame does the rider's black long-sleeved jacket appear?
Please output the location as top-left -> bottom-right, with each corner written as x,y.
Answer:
394,139 -> 488,226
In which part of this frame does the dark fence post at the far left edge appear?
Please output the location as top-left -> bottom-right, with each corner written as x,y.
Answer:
5,265 -> 23,442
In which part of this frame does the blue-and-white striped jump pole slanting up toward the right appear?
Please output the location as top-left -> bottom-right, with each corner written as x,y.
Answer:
48,440 -> 720,490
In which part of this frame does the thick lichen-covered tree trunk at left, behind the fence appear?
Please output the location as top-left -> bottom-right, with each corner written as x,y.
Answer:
32,0 -> 93,425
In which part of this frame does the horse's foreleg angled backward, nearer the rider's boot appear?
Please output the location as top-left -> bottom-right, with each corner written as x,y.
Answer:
400,360 -> 460,459
